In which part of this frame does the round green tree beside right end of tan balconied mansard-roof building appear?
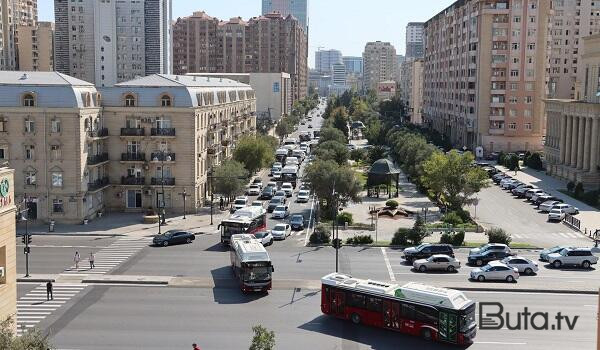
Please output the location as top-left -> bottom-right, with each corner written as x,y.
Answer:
233,136 -> 274,174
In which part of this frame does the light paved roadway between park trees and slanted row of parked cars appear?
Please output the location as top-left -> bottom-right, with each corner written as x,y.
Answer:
468,184 -> 592,248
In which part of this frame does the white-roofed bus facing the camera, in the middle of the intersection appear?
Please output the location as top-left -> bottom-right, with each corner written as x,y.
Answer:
230,234 -> 275,293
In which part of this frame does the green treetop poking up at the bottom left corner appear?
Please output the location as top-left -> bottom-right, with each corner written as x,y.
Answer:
0,317 -> 54,350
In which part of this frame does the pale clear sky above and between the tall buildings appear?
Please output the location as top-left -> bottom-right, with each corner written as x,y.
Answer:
38,0 -> 454,67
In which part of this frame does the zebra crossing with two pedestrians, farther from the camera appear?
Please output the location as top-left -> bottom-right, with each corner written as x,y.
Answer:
62,237 -> 152,275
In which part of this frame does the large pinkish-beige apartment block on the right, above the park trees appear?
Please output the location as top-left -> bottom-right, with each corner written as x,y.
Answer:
423,0 -> 550,152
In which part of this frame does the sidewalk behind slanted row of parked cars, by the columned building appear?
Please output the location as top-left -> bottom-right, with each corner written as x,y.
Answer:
496,165 -> 600,232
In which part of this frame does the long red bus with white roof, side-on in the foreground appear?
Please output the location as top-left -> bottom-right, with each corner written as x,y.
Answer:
321,273 -> 477,345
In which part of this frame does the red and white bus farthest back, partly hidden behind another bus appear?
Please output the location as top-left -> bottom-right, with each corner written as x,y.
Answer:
218,207 -> 267,244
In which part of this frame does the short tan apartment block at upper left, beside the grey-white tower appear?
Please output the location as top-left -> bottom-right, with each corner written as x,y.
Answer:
17,22 -> 54,72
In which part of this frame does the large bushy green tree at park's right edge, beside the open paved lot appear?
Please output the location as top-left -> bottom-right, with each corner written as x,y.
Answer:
421,150 -> 489,210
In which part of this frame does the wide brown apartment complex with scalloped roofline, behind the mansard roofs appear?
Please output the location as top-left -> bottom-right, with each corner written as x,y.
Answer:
173,12 -> 308,101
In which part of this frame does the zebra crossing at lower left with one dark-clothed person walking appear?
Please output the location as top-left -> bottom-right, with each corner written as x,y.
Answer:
17,283 -> 87,335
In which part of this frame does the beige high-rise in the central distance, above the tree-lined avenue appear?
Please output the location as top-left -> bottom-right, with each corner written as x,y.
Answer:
363,41 -> 398,89
